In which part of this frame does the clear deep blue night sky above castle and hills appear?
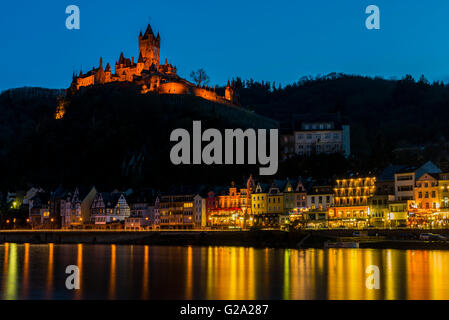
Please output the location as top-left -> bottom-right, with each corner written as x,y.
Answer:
0,0 -> 449,91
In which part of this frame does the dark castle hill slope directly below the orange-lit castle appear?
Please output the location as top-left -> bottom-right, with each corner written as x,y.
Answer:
0,84 -> 278,188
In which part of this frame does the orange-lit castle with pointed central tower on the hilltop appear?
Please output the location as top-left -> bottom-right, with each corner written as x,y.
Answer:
56,25 -> 238,119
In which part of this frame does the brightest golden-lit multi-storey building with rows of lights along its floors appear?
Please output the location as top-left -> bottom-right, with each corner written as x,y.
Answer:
328,177 -> 376,228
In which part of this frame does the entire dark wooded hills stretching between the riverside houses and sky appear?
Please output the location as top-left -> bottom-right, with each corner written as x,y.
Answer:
0,74 -> 449,191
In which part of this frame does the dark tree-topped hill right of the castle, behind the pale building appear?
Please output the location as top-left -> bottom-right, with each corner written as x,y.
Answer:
233,73 -> 449,164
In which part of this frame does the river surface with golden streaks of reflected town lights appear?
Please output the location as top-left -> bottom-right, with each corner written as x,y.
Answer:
0,243 -> 449,299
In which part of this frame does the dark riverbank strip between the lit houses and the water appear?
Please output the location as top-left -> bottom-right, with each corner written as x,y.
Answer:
0,229 -> 449,250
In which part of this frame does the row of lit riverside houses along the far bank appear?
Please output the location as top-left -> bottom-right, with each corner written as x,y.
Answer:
6,162 -> 449,230
